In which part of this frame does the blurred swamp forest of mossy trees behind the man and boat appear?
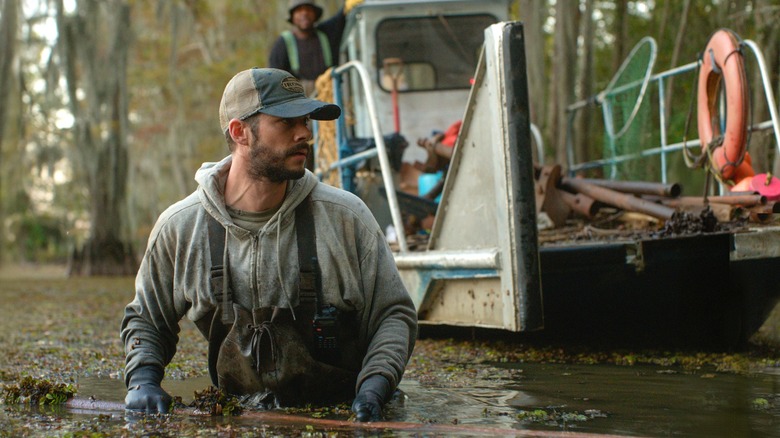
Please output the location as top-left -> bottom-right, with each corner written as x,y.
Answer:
0,0 -> 780,275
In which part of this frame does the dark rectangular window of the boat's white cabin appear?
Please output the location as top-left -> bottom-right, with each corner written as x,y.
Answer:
376,14 -> 498,92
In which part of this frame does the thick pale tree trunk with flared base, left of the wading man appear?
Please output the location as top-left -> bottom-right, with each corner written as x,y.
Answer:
57,0 -> 137,275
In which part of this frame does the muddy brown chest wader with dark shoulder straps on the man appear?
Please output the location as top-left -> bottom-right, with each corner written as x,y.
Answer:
196,197 -> 364,406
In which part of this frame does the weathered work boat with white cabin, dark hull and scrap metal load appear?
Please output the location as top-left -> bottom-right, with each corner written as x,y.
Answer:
315,0 -> 780,349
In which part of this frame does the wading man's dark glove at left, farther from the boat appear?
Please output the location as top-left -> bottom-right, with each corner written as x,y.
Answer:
125,366 -> 173,414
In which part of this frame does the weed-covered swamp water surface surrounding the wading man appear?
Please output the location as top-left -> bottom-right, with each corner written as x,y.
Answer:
0,272 -> 780,437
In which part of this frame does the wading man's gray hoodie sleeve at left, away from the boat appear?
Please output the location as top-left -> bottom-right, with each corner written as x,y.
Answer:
121,205 -> 186,383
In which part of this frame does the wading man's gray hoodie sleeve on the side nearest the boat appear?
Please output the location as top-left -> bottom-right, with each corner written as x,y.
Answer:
356,226 -> 417,391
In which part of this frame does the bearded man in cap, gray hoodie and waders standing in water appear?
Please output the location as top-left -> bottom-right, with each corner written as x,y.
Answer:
121,68 -> 417,421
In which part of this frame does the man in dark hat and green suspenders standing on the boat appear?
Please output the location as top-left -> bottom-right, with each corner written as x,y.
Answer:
268,0 -> 354,95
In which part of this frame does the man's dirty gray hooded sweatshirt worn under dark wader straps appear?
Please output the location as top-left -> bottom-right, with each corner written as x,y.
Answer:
121,156 -> 417,389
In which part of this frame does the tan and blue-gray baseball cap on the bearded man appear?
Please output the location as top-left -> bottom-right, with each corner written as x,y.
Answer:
219,67 -> 341,132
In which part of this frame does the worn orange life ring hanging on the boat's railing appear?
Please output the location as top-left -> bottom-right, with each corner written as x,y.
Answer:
697,29 -> 755,183
